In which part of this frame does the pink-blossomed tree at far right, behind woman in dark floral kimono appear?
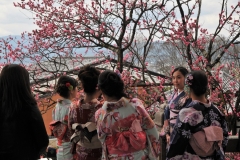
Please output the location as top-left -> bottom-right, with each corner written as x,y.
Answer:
158,0 -> 240,134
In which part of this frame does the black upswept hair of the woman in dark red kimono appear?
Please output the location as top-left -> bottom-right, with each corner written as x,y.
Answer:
78,65 -> 100,94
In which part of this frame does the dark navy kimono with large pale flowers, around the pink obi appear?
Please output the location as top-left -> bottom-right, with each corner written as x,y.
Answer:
167,100 -> 228,160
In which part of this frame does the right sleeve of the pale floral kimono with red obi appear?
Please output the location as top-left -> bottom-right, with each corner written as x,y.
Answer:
133,101 -> 160,159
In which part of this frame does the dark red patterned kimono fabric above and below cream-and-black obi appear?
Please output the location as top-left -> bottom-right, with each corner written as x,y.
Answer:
69,99 -> 102,160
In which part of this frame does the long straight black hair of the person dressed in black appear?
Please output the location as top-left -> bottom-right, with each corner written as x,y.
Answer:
0,64 -> 37,120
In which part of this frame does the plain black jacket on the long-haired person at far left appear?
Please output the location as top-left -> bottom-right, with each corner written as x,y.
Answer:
0,106 -> 49,160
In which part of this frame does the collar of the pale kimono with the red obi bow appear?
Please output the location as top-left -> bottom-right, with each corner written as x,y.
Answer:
102,97 -> 129,111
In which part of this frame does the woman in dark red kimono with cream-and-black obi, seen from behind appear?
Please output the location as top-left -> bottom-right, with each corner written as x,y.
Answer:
69,65 -> 102,160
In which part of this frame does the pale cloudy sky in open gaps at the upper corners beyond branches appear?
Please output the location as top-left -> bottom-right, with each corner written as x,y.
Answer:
0,0 -> 236,37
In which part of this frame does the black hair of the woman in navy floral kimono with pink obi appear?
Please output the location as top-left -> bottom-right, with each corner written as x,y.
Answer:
189,70 -> 208,96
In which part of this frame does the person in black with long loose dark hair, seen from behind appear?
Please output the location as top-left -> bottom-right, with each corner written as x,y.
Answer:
0,64 -> 49,160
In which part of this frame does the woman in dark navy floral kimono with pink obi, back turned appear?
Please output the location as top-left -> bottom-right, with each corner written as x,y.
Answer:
167,71 -> 228,160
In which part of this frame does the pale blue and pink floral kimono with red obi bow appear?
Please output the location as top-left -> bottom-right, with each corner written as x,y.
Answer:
95,97 -> 160,160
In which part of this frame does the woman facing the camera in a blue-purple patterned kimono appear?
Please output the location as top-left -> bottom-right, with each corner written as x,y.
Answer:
160,67 -> 191,144
